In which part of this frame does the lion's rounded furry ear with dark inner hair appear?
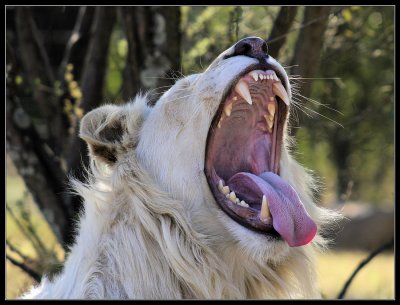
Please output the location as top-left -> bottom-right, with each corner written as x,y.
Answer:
79,105 -> 126,165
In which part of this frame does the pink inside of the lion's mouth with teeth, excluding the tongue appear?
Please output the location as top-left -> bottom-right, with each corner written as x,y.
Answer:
206,65 -> 290,233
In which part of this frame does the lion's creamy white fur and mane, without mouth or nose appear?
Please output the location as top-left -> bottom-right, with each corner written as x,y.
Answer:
24,41 -> 339,299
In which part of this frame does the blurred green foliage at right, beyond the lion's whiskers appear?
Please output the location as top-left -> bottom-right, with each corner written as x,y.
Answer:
300,7 -> 394,204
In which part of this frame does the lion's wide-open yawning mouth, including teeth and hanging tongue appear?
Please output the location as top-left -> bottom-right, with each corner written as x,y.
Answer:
205,65 -> 317,246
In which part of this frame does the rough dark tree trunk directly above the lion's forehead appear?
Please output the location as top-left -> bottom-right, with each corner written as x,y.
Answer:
119,6 -> 181,101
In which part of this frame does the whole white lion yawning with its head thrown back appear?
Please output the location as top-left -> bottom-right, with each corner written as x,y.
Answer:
23,37 -> 339,299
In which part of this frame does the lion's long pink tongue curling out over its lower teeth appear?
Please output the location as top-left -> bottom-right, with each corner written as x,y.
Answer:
227,172 -> 317,247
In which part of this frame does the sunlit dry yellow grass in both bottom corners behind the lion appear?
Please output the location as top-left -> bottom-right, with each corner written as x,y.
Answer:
6,158 -> 394,299
